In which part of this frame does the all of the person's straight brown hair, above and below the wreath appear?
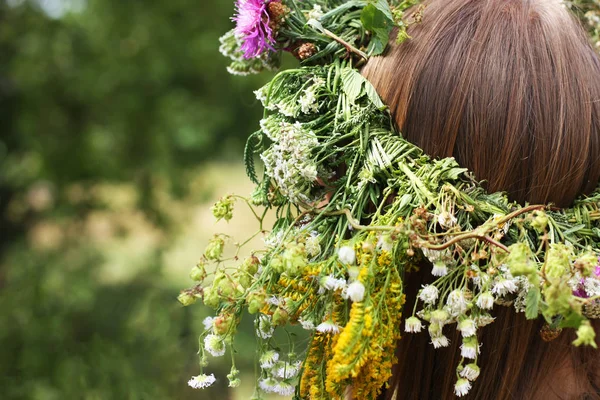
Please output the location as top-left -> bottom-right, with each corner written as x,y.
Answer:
363,0 -> 600,400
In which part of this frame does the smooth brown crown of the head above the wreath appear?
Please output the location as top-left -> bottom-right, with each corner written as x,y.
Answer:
363,0 -> 600,206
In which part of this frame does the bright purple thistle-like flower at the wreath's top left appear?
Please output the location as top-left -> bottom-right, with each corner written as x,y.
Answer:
233,0 -> 279,59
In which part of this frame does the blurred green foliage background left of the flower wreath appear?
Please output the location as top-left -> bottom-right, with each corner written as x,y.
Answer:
0,0 -> 269,400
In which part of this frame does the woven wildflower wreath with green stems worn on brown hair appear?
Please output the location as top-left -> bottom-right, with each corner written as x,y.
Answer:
179,0 -> 600,399
